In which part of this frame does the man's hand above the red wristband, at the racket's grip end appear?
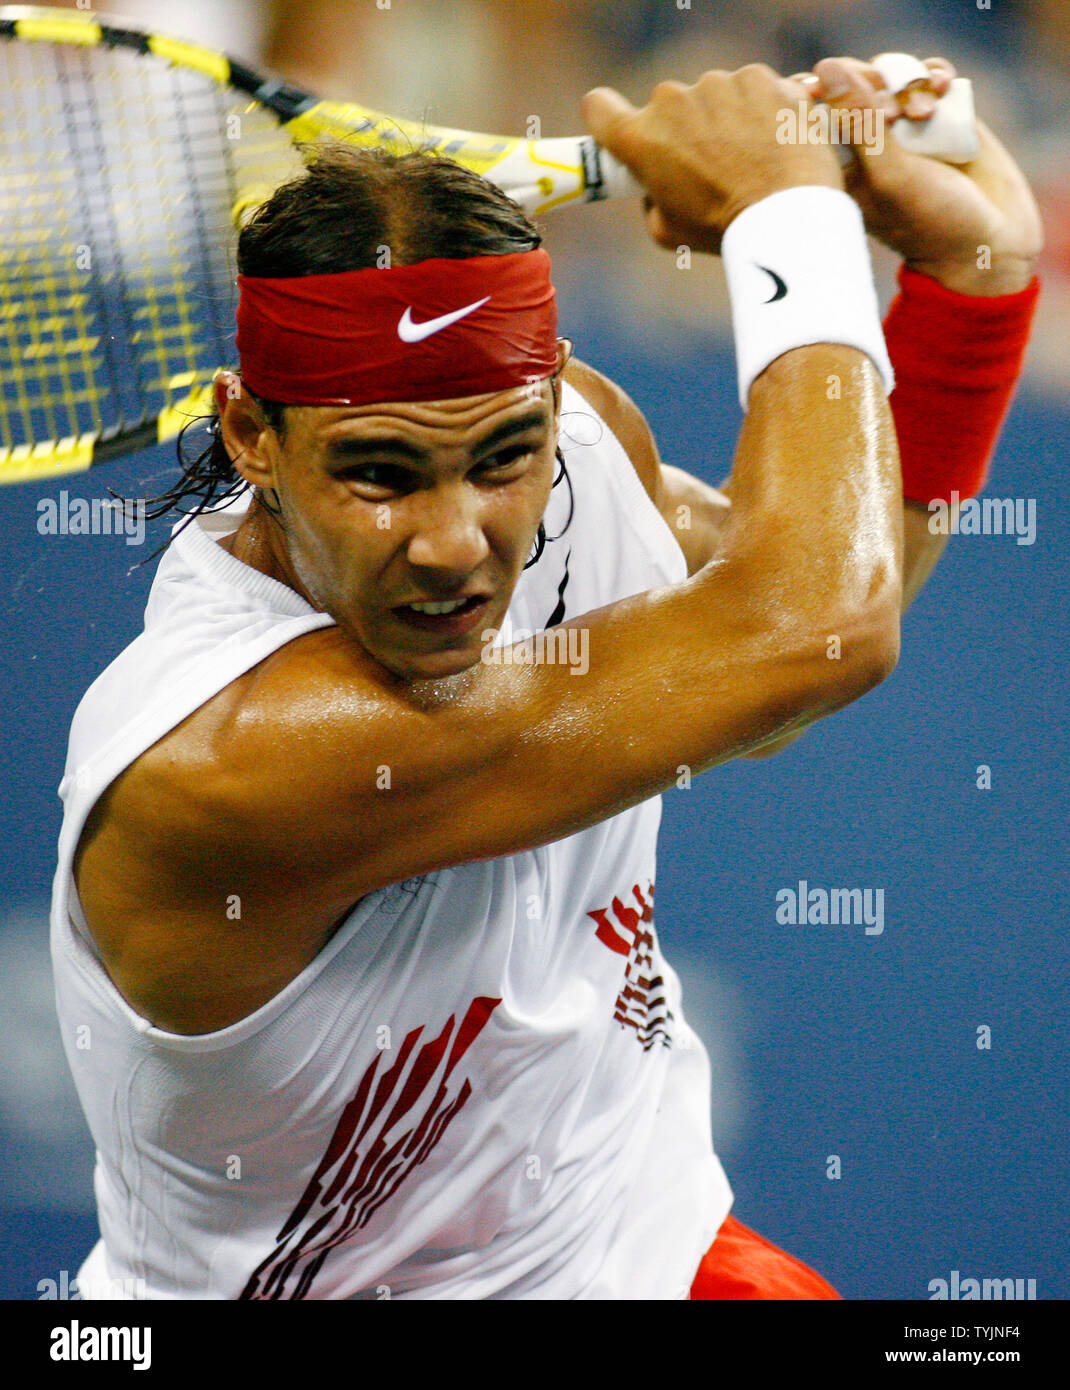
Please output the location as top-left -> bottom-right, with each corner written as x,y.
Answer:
795,58 -> 1044,295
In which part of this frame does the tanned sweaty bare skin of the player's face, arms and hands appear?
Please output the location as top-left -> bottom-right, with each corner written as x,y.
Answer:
75,48 -> 1031,1033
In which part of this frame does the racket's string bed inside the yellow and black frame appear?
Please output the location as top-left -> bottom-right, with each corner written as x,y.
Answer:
0,35 -> 258,463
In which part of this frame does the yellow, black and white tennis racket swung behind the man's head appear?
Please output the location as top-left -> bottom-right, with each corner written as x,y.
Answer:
0,6 -> 973,482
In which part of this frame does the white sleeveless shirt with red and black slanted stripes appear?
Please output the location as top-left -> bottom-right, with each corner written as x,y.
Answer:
51,384 -> 731,1300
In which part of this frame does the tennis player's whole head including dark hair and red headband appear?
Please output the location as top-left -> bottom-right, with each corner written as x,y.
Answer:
198,147 -> 567,678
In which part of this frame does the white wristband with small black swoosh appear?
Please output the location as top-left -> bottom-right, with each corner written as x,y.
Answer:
721,186 -> 895,410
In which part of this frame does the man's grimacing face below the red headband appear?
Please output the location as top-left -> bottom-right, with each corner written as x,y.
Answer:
233,366 -> 557,680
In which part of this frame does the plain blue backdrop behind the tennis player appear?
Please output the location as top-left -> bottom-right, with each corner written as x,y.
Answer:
0,296 -> 1070,1298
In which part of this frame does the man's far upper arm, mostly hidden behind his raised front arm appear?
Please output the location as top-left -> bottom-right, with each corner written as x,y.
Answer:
564,359 -> 731,575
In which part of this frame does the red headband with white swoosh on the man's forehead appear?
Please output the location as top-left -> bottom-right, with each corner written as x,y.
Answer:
238,249 -> 557,406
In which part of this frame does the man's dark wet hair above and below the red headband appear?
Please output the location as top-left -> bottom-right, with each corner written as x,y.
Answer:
146,145 -> 573,564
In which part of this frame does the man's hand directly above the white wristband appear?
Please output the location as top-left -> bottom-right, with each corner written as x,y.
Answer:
582,64 -> 843,253
